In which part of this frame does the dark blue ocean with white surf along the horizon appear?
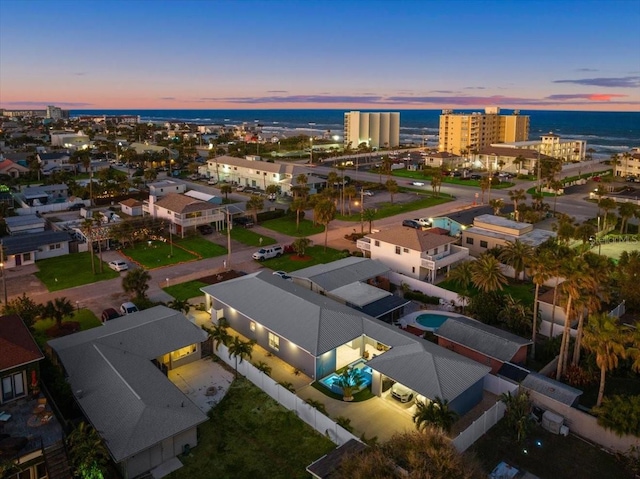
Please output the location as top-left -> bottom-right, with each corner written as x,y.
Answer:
70,109 -> 640,158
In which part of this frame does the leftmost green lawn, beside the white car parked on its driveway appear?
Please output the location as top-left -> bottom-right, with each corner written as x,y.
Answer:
36,252 -> 120,291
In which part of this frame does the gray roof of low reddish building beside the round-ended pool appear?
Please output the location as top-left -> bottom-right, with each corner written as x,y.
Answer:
435,316 -> 531,361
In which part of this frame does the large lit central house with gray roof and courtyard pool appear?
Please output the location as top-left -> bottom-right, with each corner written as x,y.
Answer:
202,271 -> 490,414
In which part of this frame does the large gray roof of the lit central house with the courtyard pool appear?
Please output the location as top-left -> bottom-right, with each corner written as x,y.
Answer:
202,272 -> 491,401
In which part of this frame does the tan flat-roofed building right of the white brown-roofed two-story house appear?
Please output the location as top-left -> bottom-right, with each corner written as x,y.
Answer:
462,215 -> 556,256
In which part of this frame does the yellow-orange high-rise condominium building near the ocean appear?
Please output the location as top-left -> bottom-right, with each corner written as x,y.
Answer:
438,107 -> 529,155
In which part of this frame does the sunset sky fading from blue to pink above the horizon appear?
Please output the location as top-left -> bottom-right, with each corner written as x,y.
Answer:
0,0 -> 640,111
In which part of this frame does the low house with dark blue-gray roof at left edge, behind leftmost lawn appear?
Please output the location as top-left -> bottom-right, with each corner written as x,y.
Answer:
0,231 -> 72,268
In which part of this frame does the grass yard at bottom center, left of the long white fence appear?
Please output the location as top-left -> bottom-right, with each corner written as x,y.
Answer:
168,379 -> 336,479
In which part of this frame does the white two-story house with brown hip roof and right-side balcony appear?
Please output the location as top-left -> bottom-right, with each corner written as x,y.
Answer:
357,226 -> 469,283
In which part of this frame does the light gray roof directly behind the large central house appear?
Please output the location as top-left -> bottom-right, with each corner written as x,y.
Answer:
291,256 -> 390,291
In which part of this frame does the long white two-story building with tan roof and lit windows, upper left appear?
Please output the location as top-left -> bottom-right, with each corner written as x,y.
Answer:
207,156 -> 326,194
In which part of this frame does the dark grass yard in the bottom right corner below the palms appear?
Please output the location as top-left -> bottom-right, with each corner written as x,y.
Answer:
469,421 -> 633,479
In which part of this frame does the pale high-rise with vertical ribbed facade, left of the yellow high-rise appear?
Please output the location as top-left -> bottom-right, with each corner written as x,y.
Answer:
344,111 -> 400,149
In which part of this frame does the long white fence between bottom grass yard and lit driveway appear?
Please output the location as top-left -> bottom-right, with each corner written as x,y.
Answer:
216,344 -> 359,446
